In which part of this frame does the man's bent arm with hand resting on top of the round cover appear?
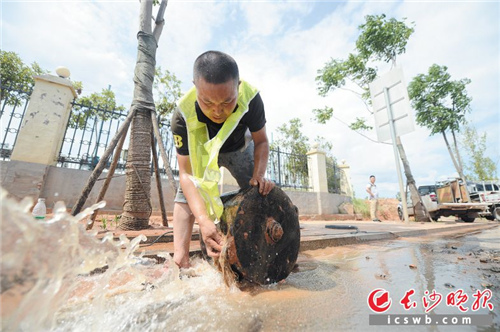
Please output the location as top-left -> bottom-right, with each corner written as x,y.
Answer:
250,126 -> 274,196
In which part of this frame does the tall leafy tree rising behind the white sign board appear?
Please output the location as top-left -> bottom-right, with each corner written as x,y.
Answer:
313,14 -> 425,220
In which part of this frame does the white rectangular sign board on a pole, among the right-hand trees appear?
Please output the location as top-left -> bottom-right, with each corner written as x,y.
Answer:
369,68 -> 415,142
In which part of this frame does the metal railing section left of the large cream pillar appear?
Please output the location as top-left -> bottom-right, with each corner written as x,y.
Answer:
0,82 -> 33,160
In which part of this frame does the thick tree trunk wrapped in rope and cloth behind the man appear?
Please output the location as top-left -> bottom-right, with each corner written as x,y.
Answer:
119,0 -> 167,230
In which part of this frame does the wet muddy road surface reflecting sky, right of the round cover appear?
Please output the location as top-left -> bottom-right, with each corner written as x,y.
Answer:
274,227 -> 500,331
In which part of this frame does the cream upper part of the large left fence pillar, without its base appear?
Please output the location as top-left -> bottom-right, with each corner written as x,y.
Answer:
10,75 -> 77,166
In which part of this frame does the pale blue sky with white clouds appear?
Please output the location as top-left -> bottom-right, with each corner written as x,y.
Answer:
0,0 -> 500,198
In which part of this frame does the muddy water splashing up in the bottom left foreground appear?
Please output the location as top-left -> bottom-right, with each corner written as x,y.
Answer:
0,189 -> 254,331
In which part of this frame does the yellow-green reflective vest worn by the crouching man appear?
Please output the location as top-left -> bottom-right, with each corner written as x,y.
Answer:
178,81 -> 259,221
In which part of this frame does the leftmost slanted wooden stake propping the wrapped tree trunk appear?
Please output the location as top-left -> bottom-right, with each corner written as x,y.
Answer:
71,106 -> 136,216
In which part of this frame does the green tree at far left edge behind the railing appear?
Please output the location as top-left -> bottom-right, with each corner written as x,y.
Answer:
0,50 -> 48,105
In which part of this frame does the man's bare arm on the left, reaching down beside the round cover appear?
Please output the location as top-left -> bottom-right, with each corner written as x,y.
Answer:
177,154 -> 222,257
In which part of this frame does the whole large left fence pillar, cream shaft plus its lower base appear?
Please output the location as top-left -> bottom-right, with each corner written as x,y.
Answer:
0,74 -> 76,200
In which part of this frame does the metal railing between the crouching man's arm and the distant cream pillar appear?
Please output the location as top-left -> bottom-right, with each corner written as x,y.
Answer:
267,148 -> 311,190
